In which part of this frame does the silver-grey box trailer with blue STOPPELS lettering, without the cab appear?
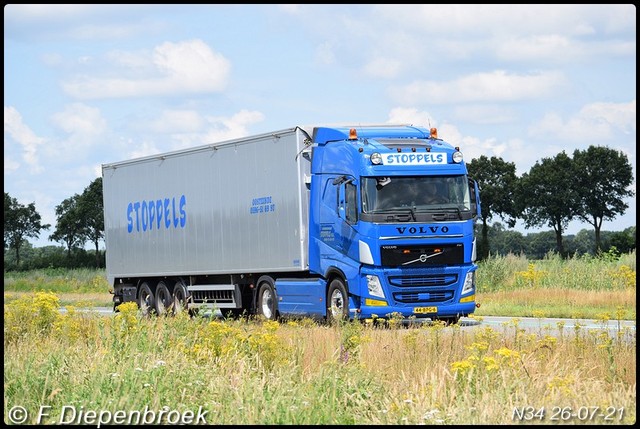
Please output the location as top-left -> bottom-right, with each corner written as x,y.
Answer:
102,127 -> 310,308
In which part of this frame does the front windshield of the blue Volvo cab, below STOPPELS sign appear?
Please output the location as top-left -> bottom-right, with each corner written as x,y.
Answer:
362,175 -> 471,214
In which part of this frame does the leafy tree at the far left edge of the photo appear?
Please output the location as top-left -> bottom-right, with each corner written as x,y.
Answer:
4,192 -> 51,266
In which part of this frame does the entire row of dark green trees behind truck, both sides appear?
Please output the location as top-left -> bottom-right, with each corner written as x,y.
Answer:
4,146 -> 635,270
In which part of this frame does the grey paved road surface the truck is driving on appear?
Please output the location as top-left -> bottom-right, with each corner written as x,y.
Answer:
60,307 -> 636,338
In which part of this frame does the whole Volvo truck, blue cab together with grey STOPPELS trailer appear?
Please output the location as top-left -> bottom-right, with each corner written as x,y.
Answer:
102,125 -> 480,323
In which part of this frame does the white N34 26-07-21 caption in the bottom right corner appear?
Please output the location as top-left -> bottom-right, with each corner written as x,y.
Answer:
512,406 -> 624,422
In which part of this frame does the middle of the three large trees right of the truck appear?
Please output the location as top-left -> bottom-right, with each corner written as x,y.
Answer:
516,151 -> 579,257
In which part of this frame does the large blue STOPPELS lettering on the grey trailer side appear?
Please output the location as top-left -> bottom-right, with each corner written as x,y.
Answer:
127,195 -> 187,233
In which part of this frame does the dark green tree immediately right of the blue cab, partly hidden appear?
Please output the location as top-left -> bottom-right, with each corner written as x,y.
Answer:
467,155 -> 518,259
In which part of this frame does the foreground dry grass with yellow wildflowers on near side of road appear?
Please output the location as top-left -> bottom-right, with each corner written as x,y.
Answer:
4,304 -> 636,425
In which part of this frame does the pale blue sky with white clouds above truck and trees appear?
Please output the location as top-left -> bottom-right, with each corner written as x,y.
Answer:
4,4 -> 637,247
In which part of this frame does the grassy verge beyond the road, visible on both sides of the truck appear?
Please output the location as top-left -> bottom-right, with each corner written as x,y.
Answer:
4,250 -> 636,320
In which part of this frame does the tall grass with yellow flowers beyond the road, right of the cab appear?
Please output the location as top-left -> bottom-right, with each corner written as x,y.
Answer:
476,251 -> 636,320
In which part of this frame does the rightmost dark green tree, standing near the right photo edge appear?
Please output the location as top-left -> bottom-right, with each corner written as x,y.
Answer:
573,146 -> 634,253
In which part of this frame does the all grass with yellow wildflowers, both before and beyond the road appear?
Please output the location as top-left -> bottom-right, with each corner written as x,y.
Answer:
4,253 -> 636,425
